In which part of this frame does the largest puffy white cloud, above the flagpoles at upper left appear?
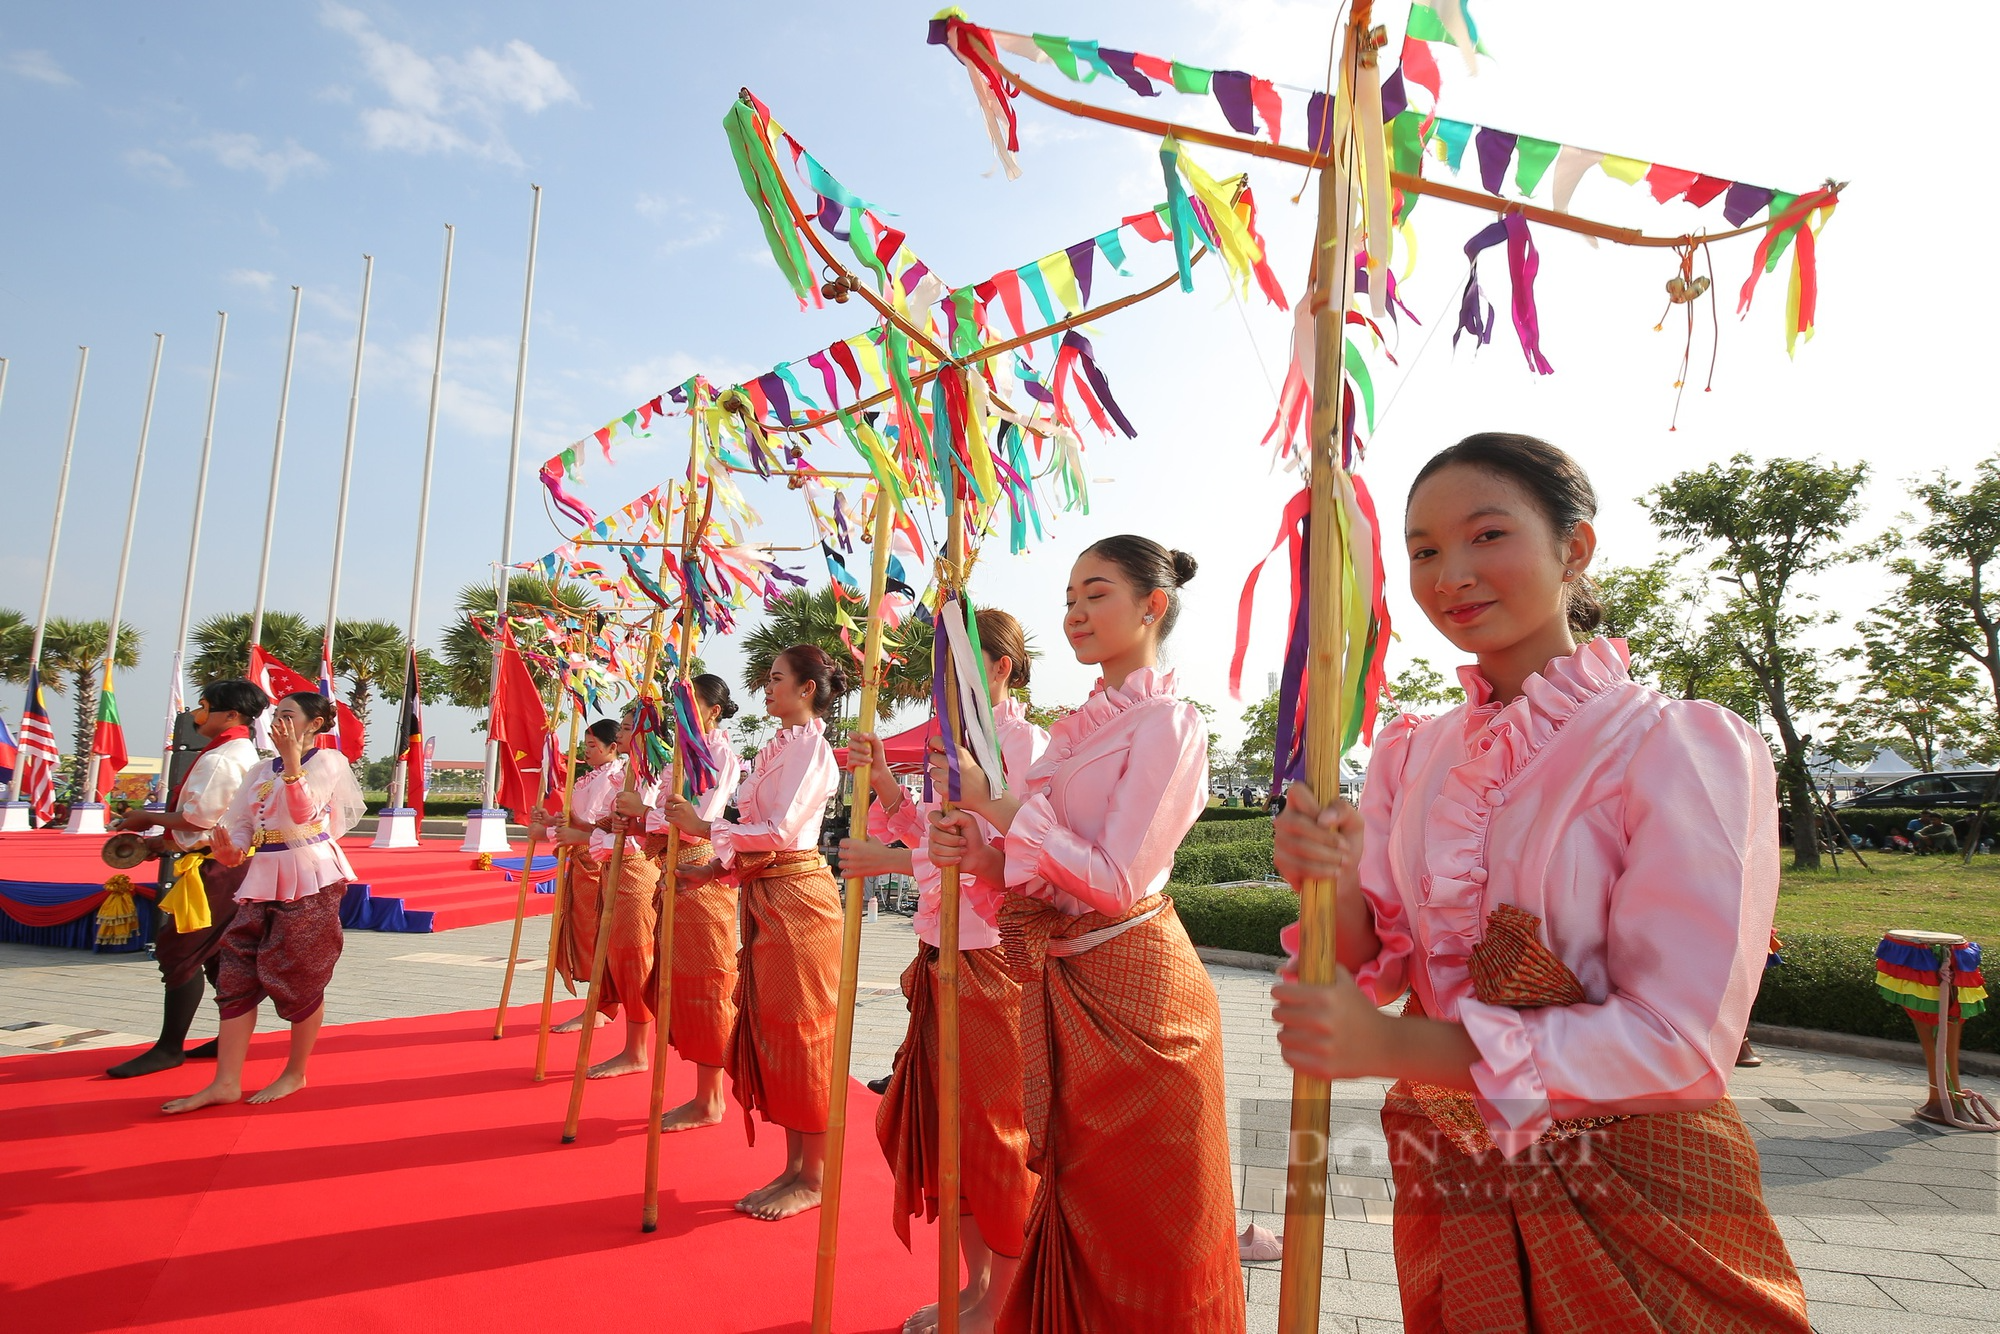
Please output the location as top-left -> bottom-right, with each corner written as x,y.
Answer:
320,0 -> 580,164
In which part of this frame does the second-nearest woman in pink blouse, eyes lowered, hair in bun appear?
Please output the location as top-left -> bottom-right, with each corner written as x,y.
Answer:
930,536 -> 1244,1334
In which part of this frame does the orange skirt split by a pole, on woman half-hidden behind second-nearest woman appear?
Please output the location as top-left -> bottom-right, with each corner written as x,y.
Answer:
876,944 -> 1036,1256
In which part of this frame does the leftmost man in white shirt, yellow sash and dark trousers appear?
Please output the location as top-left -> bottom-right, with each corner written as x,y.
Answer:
104,680 -> 270,1080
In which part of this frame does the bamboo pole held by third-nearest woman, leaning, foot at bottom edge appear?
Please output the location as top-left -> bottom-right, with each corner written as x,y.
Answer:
812,490 -> 896,1334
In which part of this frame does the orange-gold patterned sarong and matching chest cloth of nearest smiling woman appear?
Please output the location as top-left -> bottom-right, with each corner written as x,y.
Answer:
1382,906 -> 1810,1334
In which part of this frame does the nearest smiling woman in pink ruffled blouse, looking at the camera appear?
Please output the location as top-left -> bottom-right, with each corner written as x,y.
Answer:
1274,434 -> 1808,1332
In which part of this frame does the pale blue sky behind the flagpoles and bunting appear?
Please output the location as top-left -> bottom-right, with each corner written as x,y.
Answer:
0,0 -> 1994,756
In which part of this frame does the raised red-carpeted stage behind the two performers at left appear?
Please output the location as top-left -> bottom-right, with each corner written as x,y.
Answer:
0,830 -> 552,932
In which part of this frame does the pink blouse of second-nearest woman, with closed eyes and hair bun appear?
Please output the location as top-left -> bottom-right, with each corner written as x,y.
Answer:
1006,668 -> 1208,918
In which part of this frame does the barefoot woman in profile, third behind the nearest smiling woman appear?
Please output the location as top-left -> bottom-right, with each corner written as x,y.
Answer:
660,644 -> 848,1220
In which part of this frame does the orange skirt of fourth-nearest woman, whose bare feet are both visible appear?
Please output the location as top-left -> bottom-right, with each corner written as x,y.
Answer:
724,852 -> 840,1144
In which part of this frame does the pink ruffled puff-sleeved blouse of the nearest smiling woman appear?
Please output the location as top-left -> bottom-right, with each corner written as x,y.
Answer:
1312,638 -> 1778,1154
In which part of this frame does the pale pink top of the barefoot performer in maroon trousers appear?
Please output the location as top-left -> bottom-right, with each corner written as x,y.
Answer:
216,750 -> 366,902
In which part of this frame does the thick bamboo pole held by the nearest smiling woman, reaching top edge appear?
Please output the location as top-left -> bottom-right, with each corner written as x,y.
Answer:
1278,13 -> 1374,1334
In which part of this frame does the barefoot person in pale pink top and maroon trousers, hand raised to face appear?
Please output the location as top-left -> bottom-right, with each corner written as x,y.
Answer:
160,692 -> 366,1114
